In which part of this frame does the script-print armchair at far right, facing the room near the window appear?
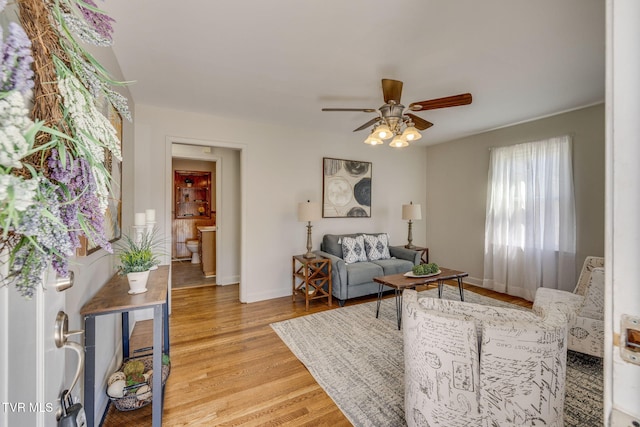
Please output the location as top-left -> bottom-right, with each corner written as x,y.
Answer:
533,256 -> 604,357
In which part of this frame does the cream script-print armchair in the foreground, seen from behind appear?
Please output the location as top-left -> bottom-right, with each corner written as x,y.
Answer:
402,289 -> 567,427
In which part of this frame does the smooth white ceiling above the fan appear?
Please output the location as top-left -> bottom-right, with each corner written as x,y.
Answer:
100,0 -> 605,144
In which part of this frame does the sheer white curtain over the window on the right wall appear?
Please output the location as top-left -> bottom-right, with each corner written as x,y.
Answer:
483,136 -> 576,301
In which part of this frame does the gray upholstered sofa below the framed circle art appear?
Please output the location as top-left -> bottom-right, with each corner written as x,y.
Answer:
315,233 -> 420,307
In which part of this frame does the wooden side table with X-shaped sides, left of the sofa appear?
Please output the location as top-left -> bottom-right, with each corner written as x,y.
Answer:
291,255 -> 331,311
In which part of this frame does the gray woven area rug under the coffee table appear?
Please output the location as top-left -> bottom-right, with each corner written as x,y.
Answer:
271,286 -> 603,427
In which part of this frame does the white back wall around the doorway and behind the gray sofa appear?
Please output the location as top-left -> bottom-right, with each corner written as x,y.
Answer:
135,105 -> 426,302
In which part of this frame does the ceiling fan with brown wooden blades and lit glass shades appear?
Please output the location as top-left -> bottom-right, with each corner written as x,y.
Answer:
322,79 -> 472,147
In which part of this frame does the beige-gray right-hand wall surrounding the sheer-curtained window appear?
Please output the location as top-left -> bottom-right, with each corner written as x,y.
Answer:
425,104 -> 605,285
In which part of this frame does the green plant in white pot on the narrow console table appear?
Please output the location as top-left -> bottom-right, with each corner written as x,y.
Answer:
116,232 -> 160,294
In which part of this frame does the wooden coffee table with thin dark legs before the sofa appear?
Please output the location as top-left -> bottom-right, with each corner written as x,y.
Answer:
373,267 -> 469,330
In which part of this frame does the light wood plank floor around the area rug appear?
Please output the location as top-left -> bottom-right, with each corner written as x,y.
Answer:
103,285 -> 531,427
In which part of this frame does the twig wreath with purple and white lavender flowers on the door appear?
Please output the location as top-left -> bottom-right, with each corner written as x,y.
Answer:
0,0 -> 131,298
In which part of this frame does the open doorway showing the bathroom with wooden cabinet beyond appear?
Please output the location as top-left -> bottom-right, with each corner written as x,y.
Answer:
165,137 -> 246,301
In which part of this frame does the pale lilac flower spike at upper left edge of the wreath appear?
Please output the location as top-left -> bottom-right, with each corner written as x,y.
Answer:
0,22 -> 33,95
